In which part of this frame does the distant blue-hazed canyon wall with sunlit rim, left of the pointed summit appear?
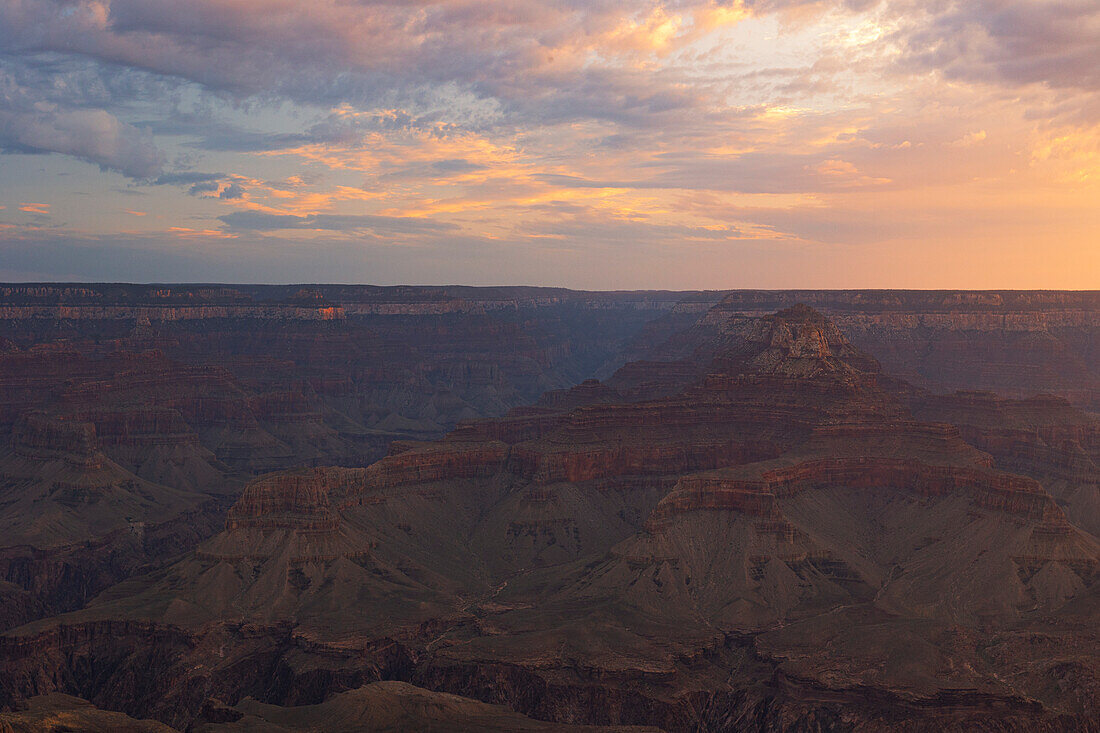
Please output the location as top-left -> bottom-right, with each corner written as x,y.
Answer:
0,285 -> 680,460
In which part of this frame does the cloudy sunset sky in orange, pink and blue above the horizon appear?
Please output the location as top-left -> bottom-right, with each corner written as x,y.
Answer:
0,0 -> 1100,289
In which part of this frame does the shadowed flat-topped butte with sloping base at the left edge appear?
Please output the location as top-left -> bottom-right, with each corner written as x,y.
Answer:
0,413 -> 221,627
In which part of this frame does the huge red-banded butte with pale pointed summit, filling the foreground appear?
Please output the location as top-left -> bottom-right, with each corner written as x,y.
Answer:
0,303 -> 1100,730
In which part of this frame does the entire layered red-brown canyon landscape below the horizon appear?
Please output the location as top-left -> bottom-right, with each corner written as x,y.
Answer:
0,283 -> 1100,733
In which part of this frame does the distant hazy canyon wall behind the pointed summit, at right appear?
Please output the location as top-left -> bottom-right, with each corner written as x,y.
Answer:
682,291 -> 1100,409
